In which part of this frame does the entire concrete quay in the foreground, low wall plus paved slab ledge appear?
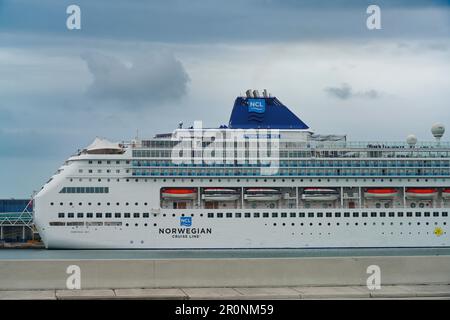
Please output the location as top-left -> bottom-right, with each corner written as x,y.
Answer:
0,255 -> 450,300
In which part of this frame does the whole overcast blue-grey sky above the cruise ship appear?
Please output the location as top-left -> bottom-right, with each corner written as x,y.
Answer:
0,0 -> 450,198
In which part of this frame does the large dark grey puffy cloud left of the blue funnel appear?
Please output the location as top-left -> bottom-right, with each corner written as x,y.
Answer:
81,51 -> 190,107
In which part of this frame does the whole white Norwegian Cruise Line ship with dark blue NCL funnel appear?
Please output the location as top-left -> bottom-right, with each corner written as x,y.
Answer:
34,90 -> 450,249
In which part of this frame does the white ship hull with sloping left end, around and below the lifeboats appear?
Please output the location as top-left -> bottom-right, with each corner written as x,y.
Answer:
35,166 -> 450,249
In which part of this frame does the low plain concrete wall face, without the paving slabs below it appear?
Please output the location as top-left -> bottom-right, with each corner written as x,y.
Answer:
0,256 -> 450,290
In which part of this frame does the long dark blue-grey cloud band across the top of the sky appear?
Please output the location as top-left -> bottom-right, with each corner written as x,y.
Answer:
0,0 -> 450,45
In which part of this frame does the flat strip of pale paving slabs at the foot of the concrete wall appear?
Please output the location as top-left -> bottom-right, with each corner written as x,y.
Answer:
0,285 -> 450,300
